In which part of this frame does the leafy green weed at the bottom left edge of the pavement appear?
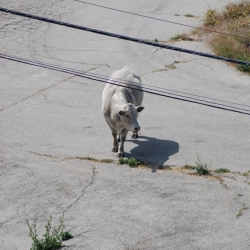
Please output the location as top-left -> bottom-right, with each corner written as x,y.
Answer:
26,215 -> 73,250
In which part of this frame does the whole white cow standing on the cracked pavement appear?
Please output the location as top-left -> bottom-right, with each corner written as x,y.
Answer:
102,67 -> 144,157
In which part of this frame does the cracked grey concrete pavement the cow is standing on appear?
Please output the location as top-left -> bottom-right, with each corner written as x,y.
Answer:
0,0 -> 250,250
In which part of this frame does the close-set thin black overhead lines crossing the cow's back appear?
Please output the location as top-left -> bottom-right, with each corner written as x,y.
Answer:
0,53 -> 250,115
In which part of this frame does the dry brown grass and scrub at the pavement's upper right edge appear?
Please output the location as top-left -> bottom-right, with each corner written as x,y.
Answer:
204,0 -> 250,73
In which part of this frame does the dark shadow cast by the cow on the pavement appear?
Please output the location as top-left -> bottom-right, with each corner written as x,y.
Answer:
126,136 -> 179,167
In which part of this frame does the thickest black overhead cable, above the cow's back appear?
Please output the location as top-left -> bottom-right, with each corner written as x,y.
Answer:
0,7 -> 250,66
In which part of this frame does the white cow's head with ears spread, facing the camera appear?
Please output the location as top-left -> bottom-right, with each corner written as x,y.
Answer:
118,103 -> 144,133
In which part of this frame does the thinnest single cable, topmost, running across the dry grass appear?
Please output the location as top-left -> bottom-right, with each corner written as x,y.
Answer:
74,0 -> 249,39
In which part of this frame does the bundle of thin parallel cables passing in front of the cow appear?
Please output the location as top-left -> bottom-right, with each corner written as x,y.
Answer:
0,53 -> 250,115
